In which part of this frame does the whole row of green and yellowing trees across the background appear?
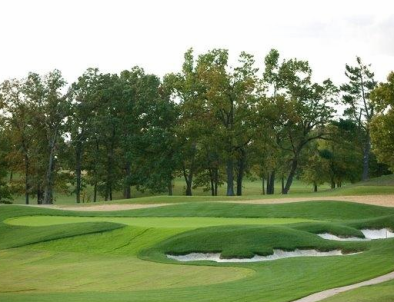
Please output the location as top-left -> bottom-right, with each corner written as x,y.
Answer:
0,49 -> 394,204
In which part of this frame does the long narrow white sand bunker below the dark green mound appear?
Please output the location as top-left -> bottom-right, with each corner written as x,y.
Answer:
167,249 -> 358,263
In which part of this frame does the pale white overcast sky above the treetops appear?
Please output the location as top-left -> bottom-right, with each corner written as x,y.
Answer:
0,0 -> 394,84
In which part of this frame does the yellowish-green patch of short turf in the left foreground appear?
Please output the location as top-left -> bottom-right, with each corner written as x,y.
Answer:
0,248 -> 253,294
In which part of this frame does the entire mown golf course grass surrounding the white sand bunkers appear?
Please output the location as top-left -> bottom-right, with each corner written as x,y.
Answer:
0,201 -> 394,302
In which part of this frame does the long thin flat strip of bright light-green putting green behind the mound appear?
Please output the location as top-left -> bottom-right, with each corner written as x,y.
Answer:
4,216 -> 316,228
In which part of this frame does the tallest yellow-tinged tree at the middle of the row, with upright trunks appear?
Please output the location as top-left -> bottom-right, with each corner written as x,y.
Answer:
197,49 -> 259,196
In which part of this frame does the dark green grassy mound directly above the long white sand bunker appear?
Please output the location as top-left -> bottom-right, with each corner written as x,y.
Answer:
143,226 -> 368,262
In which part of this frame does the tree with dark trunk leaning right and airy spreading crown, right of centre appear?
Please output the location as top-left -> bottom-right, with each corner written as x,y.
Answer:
266,51 -> 337,194
